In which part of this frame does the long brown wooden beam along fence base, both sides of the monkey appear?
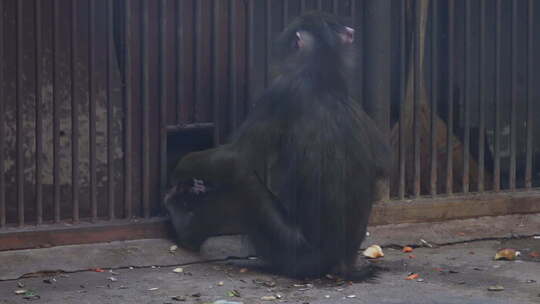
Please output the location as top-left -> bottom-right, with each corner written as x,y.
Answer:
0,190 -> 540,251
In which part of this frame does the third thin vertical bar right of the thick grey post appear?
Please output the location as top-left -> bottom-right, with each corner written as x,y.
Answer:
430,0 -> 439,196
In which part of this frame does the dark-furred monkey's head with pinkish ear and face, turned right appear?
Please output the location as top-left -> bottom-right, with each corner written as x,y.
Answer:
275,12 -> 354,69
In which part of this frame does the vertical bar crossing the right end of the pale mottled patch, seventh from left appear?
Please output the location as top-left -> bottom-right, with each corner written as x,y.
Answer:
106,0 -> 115,220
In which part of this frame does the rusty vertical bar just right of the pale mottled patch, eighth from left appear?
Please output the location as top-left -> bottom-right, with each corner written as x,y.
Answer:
124,0 -> 133,219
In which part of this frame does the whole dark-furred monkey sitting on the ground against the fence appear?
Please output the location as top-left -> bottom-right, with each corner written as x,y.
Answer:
164,12 -> 391,280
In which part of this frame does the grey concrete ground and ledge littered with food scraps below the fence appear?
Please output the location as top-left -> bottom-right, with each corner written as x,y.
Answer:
0,215 -> 540,304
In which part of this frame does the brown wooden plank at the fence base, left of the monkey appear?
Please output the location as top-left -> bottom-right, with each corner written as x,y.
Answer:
0,218 -> 169,251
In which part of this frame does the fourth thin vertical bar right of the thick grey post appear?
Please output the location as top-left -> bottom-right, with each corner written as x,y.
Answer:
446,0 -> 455,194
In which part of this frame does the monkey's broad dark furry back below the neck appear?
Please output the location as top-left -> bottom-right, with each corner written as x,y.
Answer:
265,95 -> 389,263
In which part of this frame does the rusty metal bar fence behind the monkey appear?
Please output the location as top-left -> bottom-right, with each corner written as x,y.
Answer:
0,0 -> 540,238
